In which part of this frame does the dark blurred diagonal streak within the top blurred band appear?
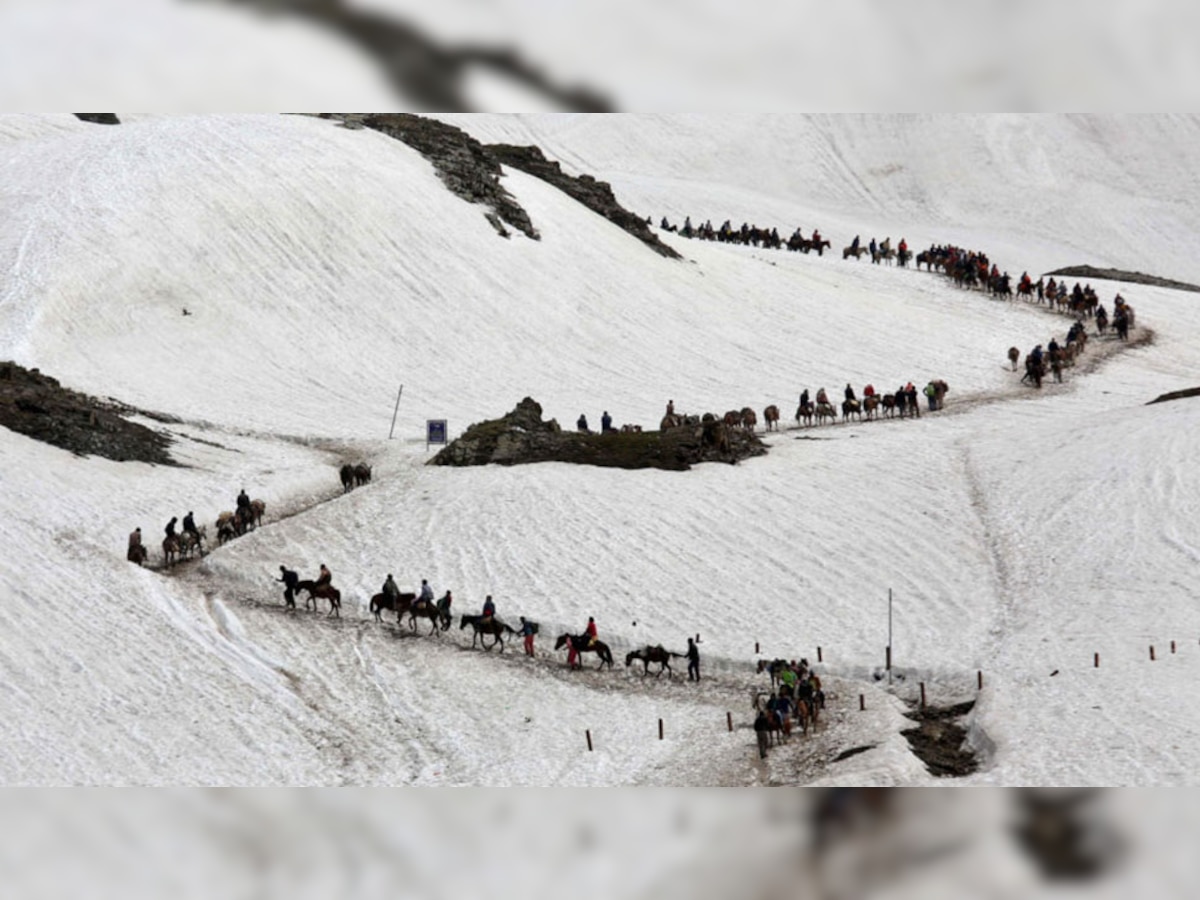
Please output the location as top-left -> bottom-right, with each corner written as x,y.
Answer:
204,0 -> 614,113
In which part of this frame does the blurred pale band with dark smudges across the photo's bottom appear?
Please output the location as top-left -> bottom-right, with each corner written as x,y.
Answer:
0,788 -> 1198,900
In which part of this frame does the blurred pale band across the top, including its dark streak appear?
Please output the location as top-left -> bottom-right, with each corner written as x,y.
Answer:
0,0 -> 1200,112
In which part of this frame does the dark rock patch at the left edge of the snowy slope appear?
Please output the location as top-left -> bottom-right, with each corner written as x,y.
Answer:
0,361 -> 179,466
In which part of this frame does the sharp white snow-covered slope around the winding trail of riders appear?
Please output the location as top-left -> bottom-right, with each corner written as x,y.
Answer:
0,115 -> 1200,784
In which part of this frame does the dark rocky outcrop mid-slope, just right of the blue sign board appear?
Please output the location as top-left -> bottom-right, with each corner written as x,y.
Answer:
428,397 -> 767,470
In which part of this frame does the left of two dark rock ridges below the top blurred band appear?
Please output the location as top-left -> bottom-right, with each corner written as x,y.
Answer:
338,113 -> 540,240
